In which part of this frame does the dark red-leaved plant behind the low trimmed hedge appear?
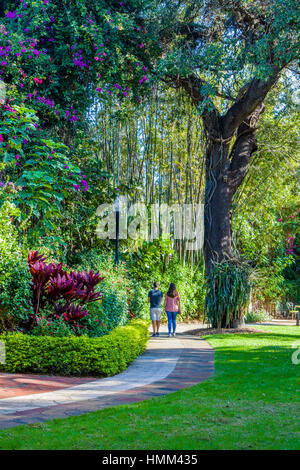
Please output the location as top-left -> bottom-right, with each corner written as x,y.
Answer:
28,251 -> 104,330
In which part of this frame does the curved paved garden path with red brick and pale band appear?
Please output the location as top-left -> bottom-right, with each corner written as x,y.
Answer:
0,324 -> 214,429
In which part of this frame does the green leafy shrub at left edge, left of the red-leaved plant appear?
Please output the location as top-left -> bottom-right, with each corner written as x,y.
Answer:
0,201 -> 32,329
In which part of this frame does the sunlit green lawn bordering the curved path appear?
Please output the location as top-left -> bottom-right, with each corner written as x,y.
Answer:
0,326 -> 300,450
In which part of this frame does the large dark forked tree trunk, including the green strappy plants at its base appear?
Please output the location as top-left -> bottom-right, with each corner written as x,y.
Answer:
176,73 -> 280,326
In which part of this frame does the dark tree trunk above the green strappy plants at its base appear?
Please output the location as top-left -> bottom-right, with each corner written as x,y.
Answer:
204,104 -> 264,273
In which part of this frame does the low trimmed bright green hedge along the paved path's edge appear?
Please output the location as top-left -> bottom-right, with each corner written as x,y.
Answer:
0,320 -> 149,377
